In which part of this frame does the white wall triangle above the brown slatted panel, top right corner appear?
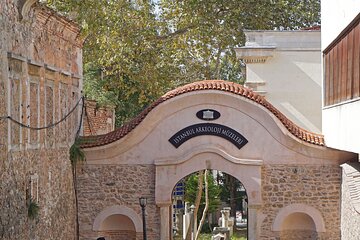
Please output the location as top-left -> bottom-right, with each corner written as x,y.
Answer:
321,0 -> 360,50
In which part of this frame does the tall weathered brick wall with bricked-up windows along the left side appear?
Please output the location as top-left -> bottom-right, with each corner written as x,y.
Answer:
0,0 -> 82,240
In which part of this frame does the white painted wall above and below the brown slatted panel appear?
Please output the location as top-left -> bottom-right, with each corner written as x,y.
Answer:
321,0 -> 360,153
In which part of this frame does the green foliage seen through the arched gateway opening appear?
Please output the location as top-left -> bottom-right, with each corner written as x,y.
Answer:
185,171 -> 221,213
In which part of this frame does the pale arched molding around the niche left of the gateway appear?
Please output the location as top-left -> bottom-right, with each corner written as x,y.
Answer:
93,205 -> 143,232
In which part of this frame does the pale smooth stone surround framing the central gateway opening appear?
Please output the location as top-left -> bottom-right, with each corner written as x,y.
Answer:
155,149 -> 262,239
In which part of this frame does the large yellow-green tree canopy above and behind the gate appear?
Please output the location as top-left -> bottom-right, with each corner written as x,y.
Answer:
47,0 -> 320,124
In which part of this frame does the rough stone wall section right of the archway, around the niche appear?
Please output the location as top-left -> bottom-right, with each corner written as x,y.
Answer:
261,165 -> 341,240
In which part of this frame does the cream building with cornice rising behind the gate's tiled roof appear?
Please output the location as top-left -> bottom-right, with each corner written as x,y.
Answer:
237,31 -> 322,133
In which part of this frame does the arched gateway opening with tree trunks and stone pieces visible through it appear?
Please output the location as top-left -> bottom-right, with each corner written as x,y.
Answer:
170,169 -> 248,240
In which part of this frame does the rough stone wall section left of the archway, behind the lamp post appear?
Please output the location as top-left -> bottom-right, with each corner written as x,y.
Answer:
78,164 -> 160,240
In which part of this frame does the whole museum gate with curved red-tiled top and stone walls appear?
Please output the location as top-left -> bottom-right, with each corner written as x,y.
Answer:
78,81 -> 357,240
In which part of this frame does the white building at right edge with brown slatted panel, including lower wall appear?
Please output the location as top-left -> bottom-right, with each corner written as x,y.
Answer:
321,0 -> 360,240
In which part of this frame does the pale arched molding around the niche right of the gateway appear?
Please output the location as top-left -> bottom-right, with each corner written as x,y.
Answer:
272,203 -> 326,232
